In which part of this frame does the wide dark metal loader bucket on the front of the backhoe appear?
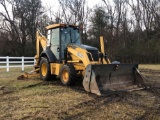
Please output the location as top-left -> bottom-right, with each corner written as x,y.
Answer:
83,64 -> 145,95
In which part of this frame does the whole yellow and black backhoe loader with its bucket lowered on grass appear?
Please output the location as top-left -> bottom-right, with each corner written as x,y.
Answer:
19,24 -> 145,95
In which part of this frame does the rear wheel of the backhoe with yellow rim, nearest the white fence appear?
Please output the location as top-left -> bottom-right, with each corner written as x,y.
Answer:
40,57 -> 51,80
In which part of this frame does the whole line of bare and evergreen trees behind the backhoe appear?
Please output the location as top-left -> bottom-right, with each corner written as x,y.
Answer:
0,0 -> 160,63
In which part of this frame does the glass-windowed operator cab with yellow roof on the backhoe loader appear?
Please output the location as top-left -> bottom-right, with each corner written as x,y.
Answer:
46,24 -> 81,61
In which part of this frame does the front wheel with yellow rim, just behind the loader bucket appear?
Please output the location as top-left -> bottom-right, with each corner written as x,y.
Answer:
60,64 -> 77,86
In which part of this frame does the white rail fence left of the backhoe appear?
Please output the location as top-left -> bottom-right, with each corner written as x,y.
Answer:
0,56 -> 36,72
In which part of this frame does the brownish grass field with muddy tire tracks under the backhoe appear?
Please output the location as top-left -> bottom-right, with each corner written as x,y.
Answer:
0,65 -> 160,120
